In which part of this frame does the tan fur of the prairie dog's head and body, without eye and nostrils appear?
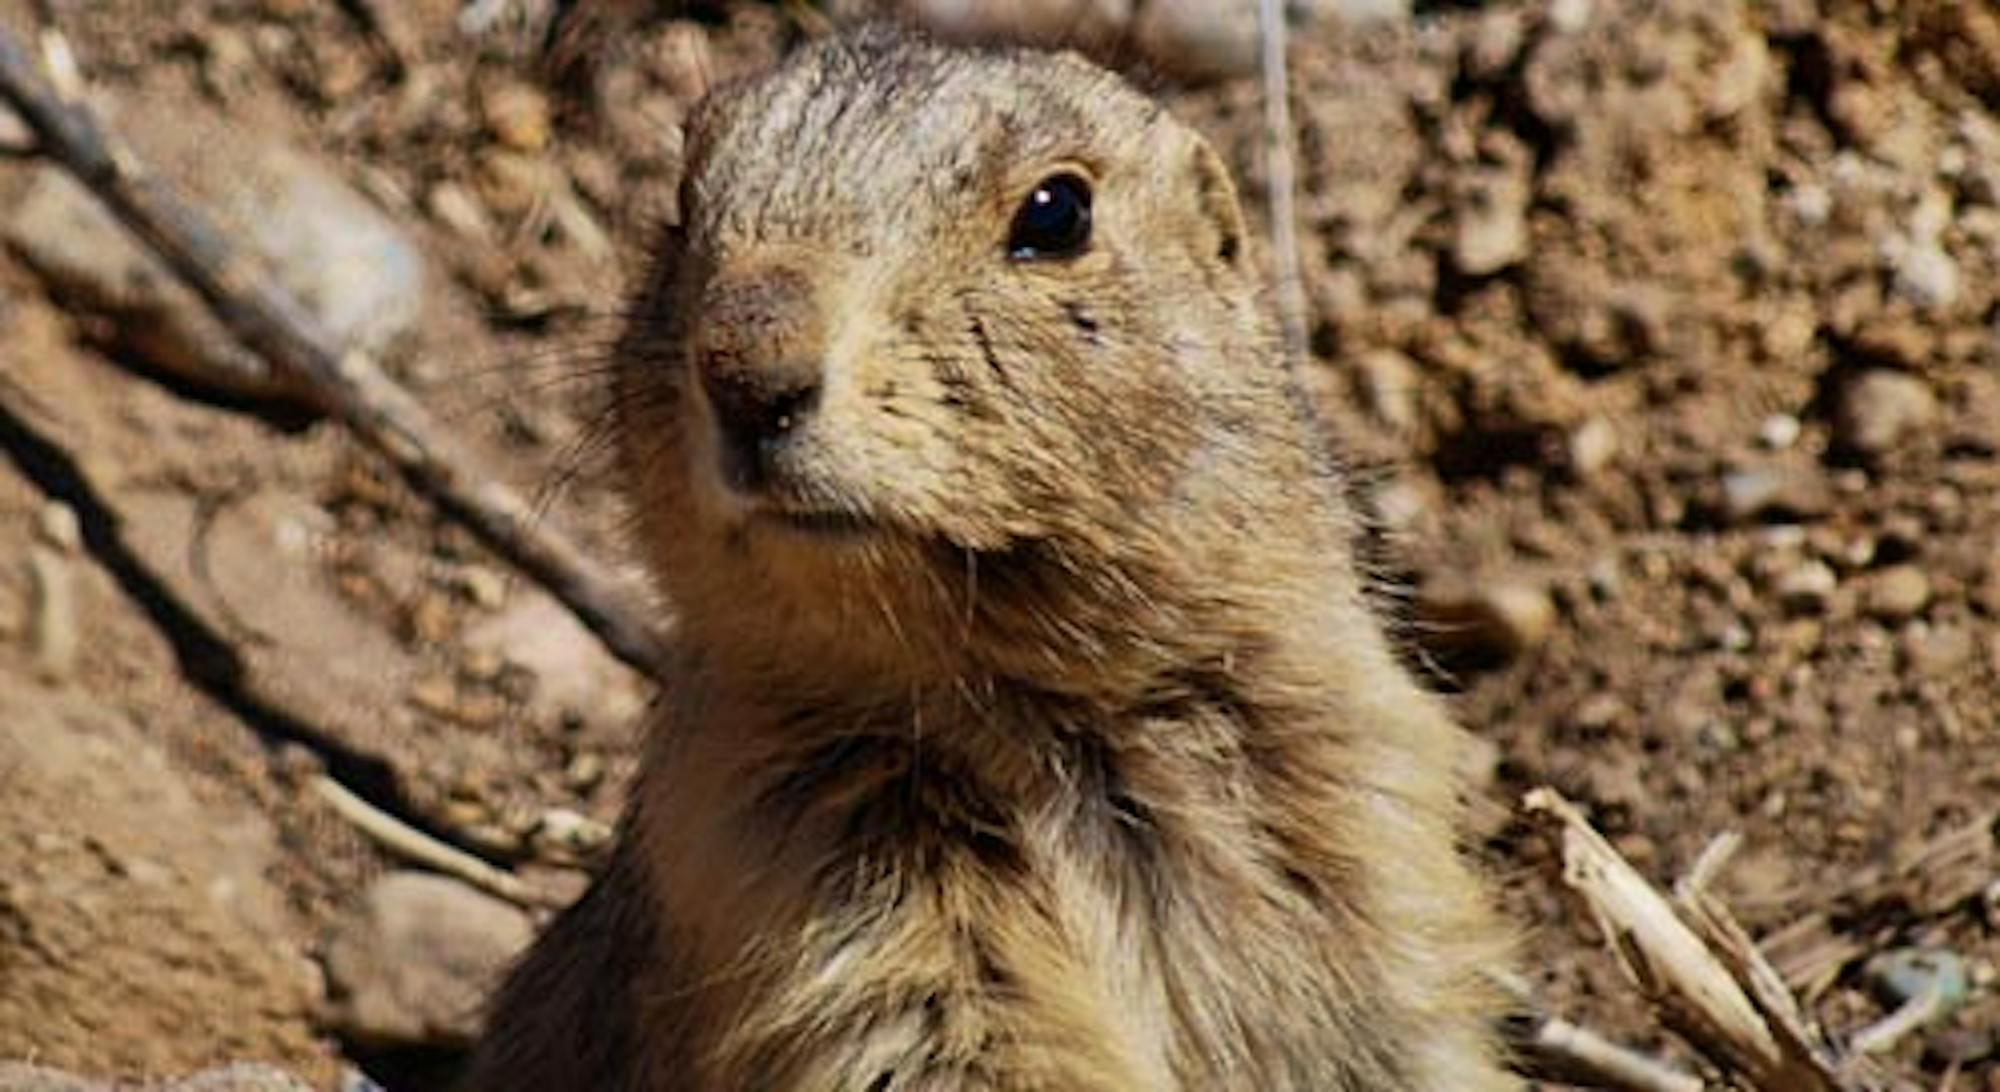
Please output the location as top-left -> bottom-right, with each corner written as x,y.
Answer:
472,30 -> 1514,1092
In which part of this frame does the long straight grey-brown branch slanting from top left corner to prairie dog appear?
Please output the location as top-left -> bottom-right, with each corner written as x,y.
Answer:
0,28 -> 662,674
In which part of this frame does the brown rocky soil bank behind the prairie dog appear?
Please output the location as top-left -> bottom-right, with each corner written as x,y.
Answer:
0,0 -> 2000,1090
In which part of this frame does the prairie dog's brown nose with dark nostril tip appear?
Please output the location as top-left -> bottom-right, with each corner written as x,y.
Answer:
694,264 -> 826,480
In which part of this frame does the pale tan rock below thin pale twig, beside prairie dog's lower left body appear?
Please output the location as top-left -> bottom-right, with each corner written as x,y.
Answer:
326,872 -> 534,1046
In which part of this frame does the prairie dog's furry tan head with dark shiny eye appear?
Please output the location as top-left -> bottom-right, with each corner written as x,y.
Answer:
616,30 -> 1320,674
